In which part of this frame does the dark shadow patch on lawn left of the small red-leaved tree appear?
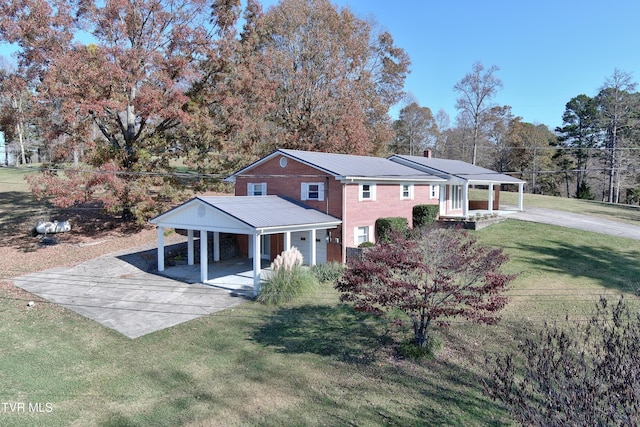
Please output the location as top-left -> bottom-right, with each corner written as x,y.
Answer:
253,304 -> 392,363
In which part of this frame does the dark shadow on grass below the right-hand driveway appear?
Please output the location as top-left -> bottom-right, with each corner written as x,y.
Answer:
513,239 -> 640,291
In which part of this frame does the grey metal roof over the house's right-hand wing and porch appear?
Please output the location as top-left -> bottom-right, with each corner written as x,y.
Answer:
389,154 -> 525,184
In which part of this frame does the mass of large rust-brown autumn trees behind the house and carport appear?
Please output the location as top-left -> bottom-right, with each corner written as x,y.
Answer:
0,0 -> 409,221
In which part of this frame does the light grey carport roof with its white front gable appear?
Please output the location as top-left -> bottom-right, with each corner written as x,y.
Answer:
151,196 -> 342,232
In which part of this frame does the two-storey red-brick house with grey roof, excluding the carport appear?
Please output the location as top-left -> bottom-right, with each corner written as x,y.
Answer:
227,149 -> 524,262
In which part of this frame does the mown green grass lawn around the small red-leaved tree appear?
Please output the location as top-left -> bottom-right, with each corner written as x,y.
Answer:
0,169 -> 640,427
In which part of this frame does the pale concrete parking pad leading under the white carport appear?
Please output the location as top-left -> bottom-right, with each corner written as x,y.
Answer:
13,244 -> 253,338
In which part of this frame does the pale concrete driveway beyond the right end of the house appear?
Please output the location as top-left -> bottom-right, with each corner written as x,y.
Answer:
509,206 -> 640,240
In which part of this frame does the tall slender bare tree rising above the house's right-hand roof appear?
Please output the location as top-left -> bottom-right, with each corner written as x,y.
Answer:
453,62 -> 502,165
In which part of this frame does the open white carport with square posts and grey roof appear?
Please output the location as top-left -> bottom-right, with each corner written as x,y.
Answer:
150,196 -> 341,295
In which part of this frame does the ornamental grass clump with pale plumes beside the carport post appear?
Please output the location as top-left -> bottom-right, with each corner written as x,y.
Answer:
258,247 -> 317,305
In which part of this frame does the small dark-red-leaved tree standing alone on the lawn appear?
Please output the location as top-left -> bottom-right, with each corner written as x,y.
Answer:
336,228 -> 514,347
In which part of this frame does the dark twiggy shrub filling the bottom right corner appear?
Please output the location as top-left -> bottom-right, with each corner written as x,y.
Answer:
485,296 -> 640,426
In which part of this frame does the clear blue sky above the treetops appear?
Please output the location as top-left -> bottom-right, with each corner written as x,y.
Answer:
0,0 -> 640,129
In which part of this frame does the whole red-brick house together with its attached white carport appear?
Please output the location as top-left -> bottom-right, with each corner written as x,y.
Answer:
151,149 -> 524,289
